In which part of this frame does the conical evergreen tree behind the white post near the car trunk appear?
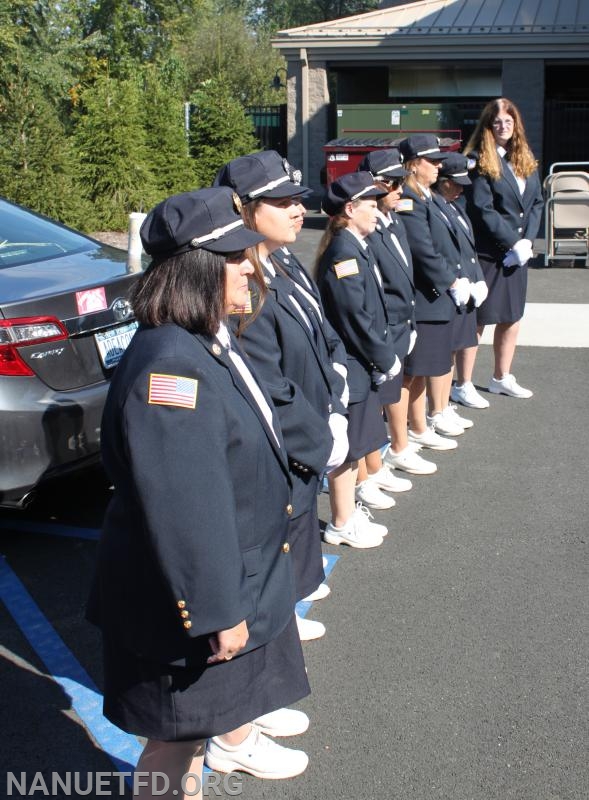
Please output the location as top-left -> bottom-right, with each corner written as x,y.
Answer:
74,76 -> 157,230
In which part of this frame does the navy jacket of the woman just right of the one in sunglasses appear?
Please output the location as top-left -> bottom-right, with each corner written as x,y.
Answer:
399,185 -> 460,322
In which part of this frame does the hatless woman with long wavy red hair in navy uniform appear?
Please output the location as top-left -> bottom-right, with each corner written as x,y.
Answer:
465,97 -> 543,399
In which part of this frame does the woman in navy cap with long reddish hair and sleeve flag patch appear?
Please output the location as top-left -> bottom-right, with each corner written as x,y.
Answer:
317,172 -> 401,548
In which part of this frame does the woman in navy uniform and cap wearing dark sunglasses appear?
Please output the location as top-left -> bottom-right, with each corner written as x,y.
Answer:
359,148 -> 436,482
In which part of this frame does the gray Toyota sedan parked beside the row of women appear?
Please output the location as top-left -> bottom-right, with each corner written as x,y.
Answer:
0,199 -> 142,507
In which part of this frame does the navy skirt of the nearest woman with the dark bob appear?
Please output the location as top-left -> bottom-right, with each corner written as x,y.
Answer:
104,613 -> 310,742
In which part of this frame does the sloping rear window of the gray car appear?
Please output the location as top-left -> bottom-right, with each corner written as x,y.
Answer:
0,200 -> 92,269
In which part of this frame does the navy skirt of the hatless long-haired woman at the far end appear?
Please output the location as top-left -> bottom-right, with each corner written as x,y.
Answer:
477,255 -> 528,325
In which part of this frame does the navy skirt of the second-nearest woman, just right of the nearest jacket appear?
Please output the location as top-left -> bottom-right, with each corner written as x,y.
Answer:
288,507 -> 325,602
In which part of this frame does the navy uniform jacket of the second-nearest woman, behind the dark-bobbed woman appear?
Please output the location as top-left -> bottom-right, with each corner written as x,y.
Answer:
230,266 -> 339,518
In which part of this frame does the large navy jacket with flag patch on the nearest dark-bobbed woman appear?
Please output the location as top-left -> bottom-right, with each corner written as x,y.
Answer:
88,324 -> 295,665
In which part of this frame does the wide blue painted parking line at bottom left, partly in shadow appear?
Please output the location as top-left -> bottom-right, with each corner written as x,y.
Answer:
0,557 -> 143,772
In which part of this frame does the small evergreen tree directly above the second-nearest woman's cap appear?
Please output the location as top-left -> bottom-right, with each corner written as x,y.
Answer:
190,78 -> 260,186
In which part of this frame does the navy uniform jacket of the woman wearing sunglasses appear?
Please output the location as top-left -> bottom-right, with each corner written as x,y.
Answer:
366,211 -> 415,361
